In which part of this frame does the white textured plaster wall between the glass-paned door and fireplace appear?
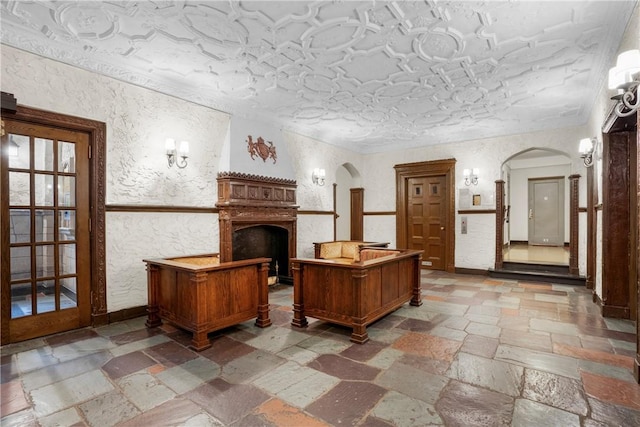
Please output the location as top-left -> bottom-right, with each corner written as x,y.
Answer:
1,46 -> 229,311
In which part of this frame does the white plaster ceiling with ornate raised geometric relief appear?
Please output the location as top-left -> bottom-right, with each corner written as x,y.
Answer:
0,0 -> 636,153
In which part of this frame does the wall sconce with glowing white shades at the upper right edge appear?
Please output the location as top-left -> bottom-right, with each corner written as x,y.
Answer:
609,49 -> 640,117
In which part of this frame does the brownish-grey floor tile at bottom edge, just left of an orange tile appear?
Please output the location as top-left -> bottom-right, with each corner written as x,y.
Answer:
118,398 -> 222,427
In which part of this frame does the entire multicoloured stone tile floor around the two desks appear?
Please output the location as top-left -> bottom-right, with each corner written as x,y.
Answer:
0,271 -> 640,427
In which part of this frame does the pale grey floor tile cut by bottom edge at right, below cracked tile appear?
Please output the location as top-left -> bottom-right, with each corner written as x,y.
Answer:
512,399 -> 580,427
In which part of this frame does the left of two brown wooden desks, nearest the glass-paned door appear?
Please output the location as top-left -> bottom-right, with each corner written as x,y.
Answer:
144,254 -> 271,351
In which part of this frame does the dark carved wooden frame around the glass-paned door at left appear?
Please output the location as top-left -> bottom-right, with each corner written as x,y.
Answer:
0,102 -> 108,344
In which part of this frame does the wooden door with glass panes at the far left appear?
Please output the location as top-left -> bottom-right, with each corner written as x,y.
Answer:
0,119 -> 91,343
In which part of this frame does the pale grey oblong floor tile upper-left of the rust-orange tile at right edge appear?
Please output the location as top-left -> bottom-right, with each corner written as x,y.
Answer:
495,344 -> 580,379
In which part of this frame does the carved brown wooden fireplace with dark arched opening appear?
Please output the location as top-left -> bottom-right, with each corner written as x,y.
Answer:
216,172 -> 298,283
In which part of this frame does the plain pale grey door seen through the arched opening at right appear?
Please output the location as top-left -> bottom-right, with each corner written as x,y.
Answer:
528,177 -> 564,246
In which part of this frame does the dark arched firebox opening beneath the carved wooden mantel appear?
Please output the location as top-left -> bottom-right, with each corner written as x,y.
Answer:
231,225 -> 293,284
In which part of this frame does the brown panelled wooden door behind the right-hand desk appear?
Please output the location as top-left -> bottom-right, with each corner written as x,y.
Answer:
407,175 -> 447,270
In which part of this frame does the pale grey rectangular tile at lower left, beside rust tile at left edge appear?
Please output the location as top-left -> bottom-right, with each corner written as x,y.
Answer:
31,370 -> 113,417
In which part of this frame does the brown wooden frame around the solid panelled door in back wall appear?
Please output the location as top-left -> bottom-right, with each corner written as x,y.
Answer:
394,159 -> 456,273
